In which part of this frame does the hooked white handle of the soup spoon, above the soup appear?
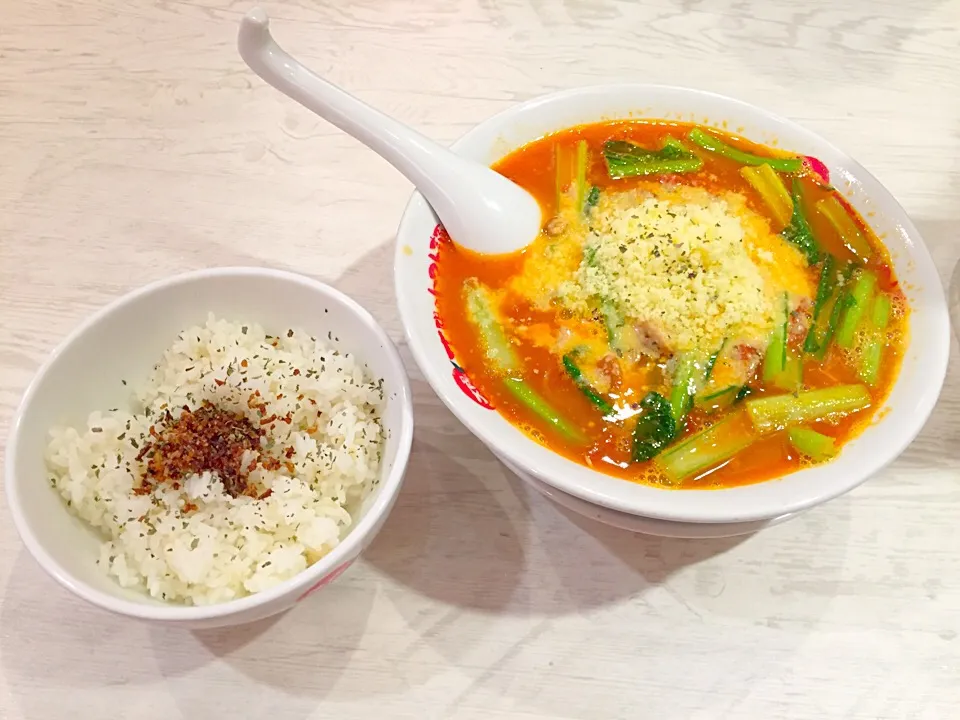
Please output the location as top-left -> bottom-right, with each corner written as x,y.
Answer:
237,8 -> 475,212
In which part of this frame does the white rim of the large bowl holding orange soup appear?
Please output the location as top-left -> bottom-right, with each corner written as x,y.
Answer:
394,83 -> 950,523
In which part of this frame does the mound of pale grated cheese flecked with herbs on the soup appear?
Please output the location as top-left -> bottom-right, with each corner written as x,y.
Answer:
561,187 -> 799,352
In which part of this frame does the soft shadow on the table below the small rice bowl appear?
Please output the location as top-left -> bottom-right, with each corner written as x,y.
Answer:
0,550 -> 376,720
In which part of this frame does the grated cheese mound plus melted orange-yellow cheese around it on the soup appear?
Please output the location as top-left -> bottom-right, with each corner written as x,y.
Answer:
512,183 -> 814,352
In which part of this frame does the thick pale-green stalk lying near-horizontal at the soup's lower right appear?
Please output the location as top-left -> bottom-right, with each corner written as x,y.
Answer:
747,385 -> 870,433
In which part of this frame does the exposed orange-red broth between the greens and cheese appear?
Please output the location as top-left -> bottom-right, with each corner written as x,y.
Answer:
435,121 -> 906,488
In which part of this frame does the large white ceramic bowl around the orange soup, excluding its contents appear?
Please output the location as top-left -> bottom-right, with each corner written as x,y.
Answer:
395,85 -> 950,523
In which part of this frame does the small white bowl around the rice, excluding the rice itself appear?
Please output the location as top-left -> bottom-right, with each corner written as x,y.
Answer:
6,268 -> 413,628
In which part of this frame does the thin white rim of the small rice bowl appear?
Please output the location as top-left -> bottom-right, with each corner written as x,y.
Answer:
4,266 -> 414,623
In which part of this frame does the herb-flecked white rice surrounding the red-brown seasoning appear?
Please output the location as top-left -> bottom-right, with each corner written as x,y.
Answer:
46,315 -> 383,605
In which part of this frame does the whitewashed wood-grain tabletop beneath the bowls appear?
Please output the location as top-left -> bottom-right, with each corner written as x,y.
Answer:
0,0 -> 960,720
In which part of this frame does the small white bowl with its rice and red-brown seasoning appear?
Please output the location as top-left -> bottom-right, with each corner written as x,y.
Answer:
5,268 -> 413,628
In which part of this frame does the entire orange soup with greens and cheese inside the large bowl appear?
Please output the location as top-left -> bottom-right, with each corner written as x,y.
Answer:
436,121 -> 908,488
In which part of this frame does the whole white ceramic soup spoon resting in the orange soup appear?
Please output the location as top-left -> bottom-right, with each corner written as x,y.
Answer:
237,8 -> 543,254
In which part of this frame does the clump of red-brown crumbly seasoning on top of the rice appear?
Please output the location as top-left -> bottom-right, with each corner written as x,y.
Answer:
137,401 -> 264,497
